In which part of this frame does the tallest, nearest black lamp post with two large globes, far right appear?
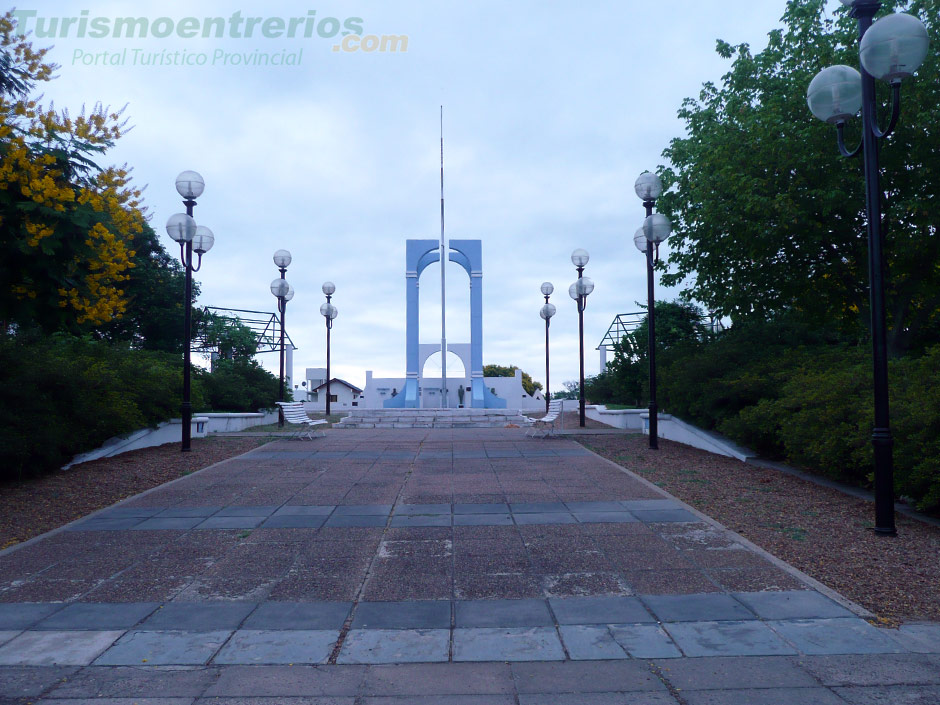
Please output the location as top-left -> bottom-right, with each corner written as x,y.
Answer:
806,0 -> 929,536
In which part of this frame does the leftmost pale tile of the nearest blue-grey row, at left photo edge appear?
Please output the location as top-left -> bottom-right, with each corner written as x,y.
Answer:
0,630 -> 124,666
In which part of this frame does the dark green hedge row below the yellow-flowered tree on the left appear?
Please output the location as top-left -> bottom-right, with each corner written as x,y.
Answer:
0,335 -> 278,479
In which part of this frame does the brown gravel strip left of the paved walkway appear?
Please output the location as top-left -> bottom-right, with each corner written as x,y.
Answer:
0,436 -> 268,549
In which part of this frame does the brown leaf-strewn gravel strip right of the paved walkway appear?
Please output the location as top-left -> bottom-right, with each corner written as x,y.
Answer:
579,435 -> 940,622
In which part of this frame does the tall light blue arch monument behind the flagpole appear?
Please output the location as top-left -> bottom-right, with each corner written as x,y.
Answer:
383,240 -> 506,409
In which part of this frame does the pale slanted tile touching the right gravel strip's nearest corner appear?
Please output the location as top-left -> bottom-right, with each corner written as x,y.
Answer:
767,617 -> 904,655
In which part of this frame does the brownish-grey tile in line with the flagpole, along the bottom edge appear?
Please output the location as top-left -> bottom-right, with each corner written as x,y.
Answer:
362,663 -> 515,697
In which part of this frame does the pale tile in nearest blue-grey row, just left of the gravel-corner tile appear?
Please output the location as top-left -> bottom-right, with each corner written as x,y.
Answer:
664,622 -> 796,656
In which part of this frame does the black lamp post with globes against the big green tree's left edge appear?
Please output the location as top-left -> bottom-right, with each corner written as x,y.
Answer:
633,171 -> 672,450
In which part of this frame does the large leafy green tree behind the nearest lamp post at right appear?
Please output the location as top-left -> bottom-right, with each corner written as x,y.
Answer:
658,0 -> 940,353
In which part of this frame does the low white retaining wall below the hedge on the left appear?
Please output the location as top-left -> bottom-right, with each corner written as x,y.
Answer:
62,411 -> 277,470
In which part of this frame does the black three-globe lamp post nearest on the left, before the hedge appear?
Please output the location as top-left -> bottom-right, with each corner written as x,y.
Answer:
166,171 -> 215,453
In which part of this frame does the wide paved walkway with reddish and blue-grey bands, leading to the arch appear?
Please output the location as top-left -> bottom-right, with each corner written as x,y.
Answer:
0,429 -> 940,705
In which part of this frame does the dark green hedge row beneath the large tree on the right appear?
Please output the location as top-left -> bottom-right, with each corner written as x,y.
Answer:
659,336 -> 940,511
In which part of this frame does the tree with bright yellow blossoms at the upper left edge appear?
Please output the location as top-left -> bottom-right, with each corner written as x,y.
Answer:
0,13 -> 145,332
